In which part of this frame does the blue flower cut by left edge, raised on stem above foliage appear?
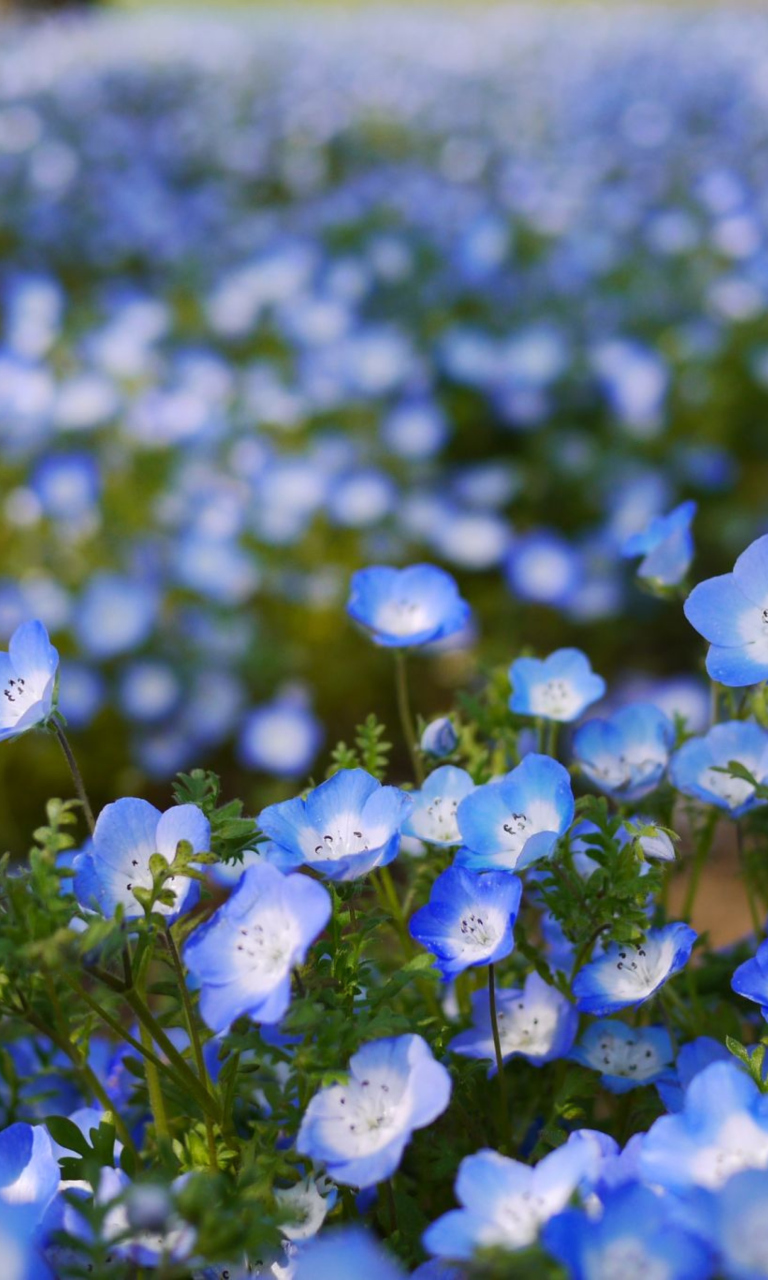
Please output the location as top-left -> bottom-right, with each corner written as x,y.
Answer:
0,622 -> 59,742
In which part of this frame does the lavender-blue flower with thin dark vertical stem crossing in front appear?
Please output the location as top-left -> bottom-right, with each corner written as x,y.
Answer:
448,970 -> 579,1074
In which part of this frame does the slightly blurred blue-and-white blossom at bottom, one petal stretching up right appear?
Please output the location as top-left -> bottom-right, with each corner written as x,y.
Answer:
422,1144 -> 594,1262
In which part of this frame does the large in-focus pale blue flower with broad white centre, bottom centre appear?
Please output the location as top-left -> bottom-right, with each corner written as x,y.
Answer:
296,1036 -> 451,1189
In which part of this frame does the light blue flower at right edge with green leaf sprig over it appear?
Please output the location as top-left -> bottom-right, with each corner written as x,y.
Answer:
669,721 -> 768,818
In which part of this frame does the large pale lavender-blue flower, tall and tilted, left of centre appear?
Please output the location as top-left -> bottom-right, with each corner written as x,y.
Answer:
184,863 -> 332,1032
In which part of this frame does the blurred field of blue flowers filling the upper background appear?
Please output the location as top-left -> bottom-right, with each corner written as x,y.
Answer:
0,0 -> 768,931
